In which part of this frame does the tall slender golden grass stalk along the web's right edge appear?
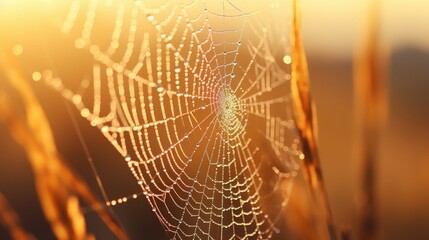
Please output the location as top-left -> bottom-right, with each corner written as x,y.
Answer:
291,0 -> 337,239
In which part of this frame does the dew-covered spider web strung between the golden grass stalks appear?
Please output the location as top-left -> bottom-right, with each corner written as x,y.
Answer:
43,0 -> 302,239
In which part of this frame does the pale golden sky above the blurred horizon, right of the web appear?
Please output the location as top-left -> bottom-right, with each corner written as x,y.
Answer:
302,0 -> 429,56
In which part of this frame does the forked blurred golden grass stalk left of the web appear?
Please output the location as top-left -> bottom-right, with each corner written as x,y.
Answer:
0,51 -> 127,239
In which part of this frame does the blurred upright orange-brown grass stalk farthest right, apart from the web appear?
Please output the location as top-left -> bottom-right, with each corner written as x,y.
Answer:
355,1 -> 388,239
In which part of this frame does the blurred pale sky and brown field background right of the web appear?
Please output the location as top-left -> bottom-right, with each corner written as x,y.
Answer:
303,0 -> 429,239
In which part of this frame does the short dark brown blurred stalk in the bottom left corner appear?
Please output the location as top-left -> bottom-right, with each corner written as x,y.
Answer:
0,193 -> 36,240
